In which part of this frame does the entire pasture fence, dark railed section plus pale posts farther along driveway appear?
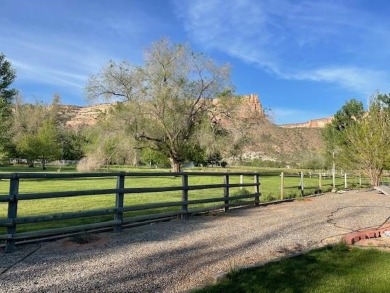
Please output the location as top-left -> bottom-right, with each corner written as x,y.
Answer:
0,172 -> 374,252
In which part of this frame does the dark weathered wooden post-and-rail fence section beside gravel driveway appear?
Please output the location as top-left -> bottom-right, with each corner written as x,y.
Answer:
0,172 -> 260,252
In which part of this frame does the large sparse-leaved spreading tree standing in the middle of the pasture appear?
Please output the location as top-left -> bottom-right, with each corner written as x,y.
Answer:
86,39 -> 231,171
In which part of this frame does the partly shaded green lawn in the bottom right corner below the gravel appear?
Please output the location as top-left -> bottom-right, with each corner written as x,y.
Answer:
195,244 -> 390,293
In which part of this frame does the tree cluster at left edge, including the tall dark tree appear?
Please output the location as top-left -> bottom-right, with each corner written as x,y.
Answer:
0,53 -> 87,169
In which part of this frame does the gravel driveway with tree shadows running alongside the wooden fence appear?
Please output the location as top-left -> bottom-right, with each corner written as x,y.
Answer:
0,191 -> 390,292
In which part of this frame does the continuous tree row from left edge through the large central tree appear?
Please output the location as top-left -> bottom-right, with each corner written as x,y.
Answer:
1,40 -> 259,171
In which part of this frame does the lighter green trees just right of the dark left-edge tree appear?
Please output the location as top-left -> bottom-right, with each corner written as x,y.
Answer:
3,96 -> 88,169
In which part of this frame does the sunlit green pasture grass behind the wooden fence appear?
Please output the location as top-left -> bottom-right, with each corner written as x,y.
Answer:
0,168 -> 368,233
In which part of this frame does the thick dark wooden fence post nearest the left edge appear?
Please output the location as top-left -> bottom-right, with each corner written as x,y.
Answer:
5,174 -> 19,252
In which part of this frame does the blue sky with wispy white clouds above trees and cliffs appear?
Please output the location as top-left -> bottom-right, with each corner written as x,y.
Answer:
0,0 -> 390,124
